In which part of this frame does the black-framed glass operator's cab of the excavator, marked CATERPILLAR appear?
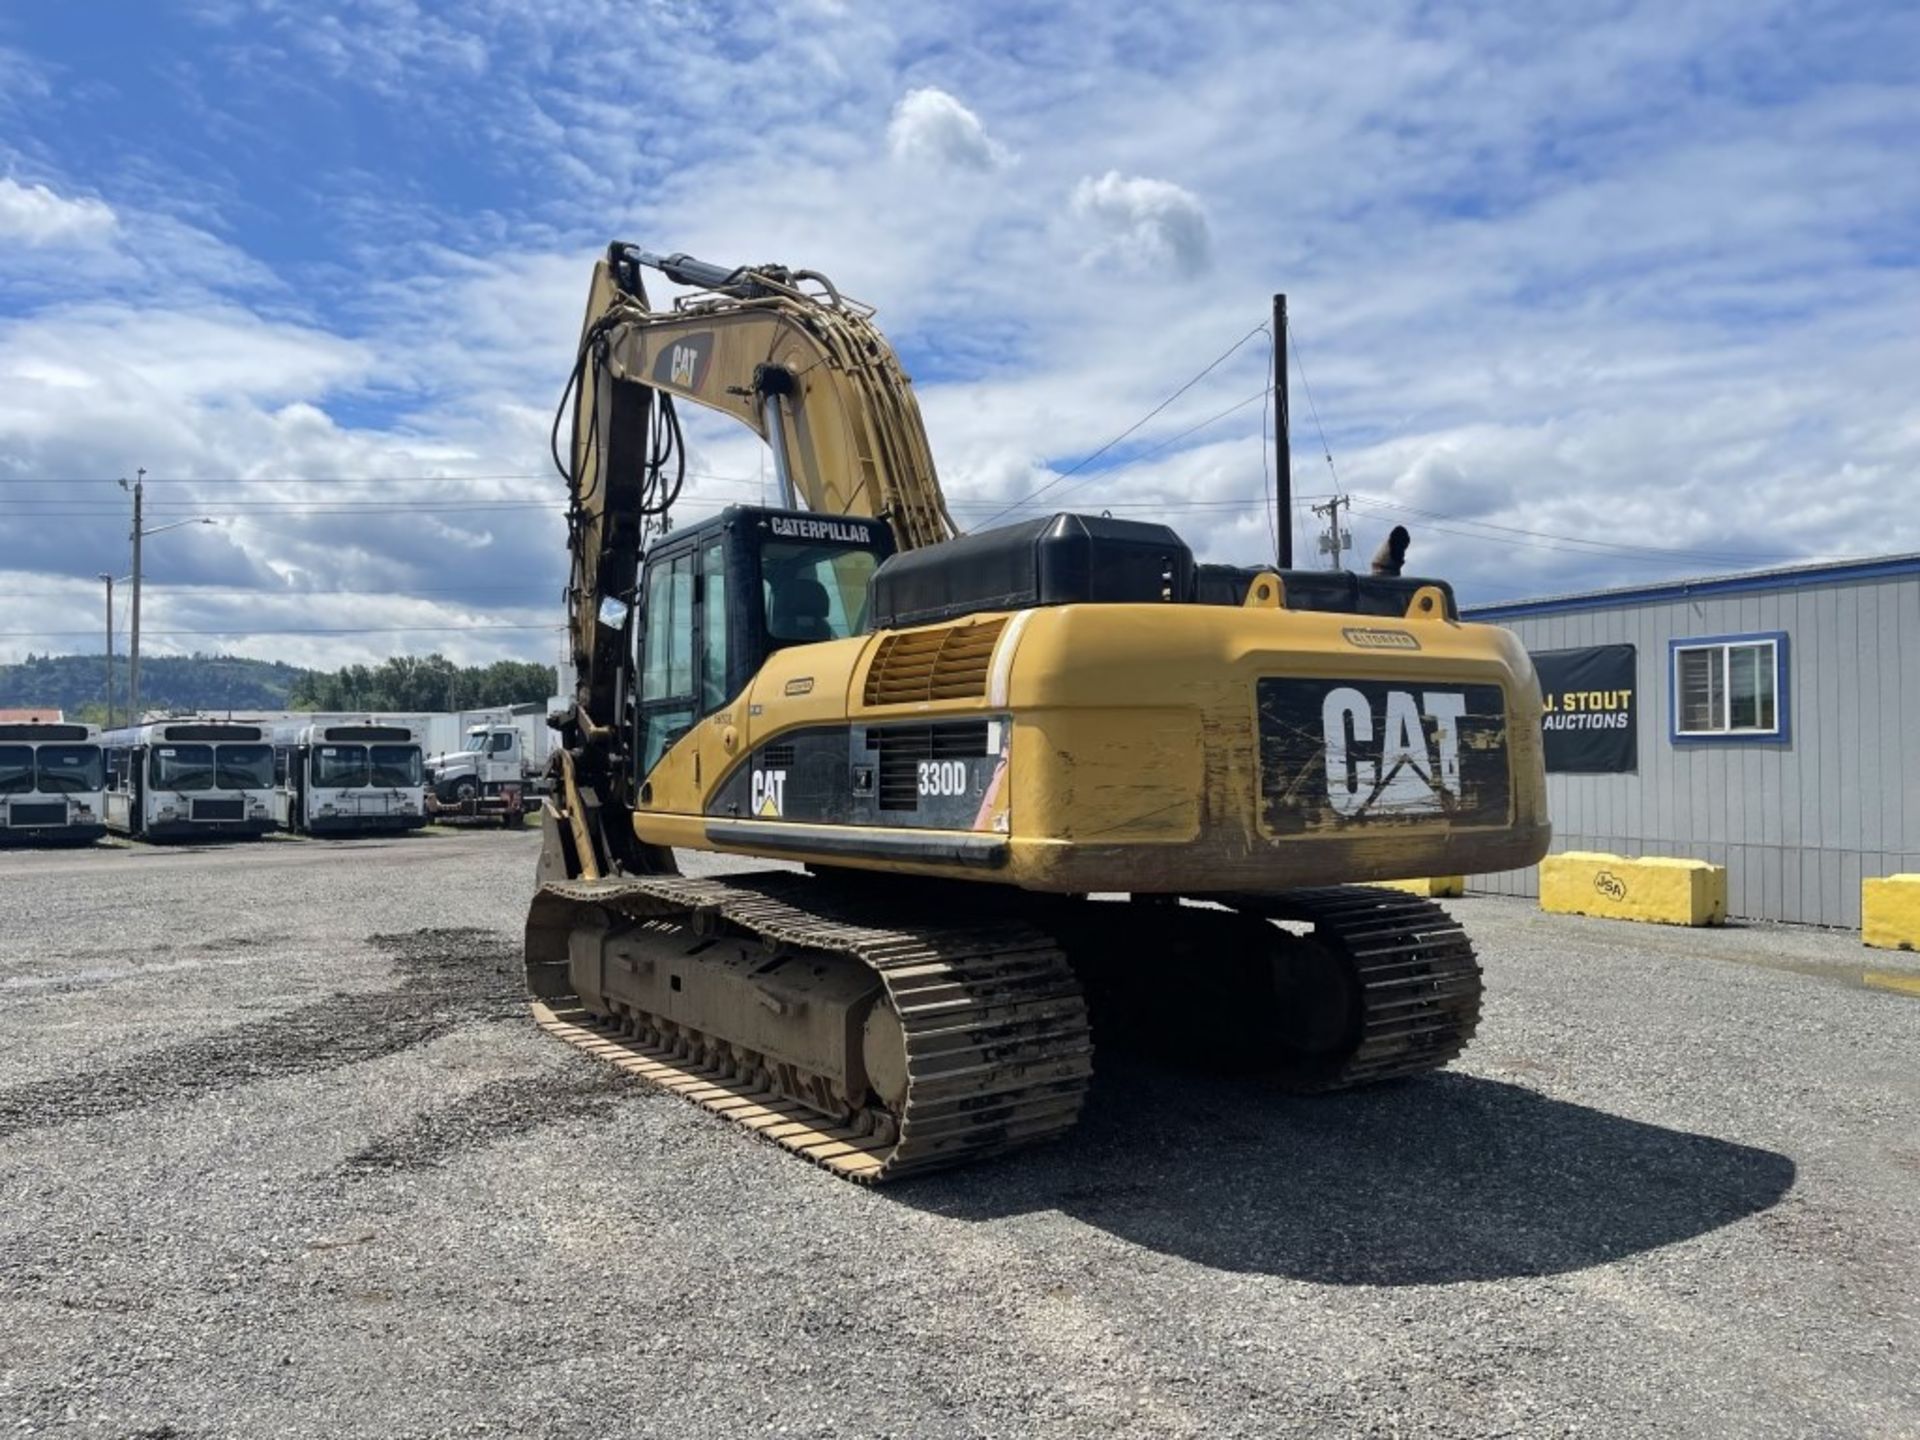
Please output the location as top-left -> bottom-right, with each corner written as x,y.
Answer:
632,505 -> 893,785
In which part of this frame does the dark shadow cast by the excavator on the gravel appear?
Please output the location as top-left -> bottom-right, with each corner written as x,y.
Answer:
887,1058 -> 1795,1284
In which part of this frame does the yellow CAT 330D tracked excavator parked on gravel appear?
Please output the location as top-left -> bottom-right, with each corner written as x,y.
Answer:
526,244 -> 1549,1181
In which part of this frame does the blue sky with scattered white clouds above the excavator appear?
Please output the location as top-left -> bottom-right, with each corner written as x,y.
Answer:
0,0 -> 1920,664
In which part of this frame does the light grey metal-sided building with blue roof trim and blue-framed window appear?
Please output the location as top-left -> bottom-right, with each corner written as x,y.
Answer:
1465,555 -> 1920,925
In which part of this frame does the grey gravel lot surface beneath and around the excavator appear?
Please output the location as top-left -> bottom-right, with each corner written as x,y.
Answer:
0,831 -> 1920,1440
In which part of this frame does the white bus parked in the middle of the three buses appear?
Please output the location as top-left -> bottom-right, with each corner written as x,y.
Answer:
100,720 -> 275,839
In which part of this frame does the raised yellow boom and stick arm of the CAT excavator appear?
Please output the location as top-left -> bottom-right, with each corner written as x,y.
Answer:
555,244 -> 956,870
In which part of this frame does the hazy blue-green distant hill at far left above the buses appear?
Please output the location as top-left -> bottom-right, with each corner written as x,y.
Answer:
0,655 -> 305,720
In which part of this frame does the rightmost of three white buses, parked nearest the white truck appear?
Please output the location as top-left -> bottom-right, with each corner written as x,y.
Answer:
273,720 -> 426,835
